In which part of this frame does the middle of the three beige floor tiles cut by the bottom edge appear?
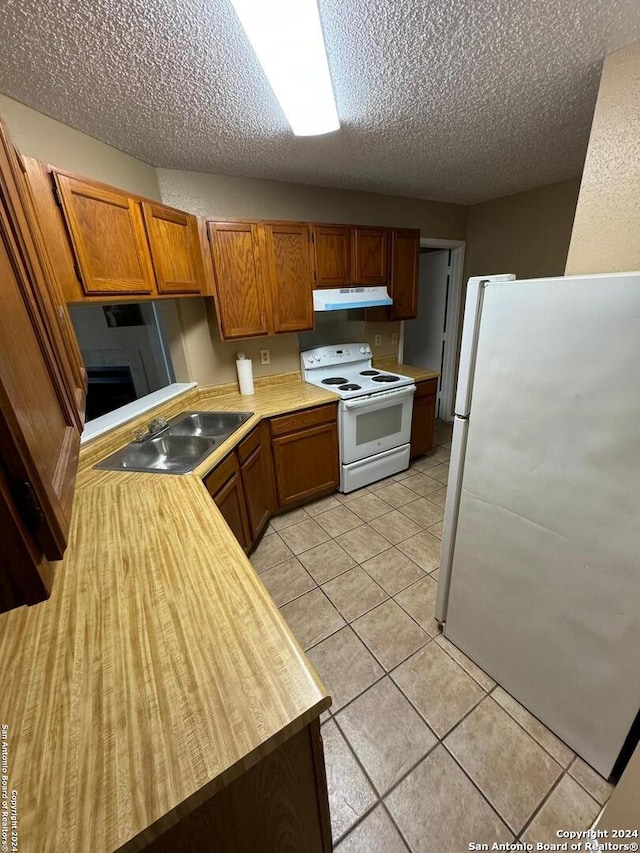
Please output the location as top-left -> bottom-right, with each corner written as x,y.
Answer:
385,746 -> 513,853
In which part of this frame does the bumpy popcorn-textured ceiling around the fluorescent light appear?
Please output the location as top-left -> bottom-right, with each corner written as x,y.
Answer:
0,0 -> 640,203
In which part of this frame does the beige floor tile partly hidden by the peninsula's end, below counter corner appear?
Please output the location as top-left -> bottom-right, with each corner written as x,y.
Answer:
322,720 -> 377,842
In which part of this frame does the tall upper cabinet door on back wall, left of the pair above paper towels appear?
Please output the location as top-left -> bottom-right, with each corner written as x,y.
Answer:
207,222 -> 269,340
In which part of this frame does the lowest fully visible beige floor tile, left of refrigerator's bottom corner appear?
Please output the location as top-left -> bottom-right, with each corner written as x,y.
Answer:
445,696 -> 562,835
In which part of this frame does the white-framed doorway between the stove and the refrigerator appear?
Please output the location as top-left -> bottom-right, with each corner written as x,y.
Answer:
402,238 -> 464,420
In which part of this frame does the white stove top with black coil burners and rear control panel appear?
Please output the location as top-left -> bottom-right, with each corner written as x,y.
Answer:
300,343 -> 413,400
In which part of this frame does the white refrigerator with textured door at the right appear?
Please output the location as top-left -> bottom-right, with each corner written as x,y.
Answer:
436,273 -> 640,776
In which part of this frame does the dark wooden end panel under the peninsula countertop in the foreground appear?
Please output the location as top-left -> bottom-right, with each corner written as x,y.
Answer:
144,719 -> 331,853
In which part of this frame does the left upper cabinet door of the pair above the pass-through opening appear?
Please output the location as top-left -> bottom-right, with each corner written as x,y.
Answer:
55,173 -> 155,296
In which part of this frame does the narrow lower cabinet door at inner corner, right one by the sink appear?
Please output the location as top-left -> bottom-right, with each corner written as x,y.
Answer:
239,421 -> 276,541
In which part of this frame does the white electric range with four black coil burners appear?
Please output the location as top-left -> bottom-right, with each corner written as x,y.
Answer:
300,343 -> 416,492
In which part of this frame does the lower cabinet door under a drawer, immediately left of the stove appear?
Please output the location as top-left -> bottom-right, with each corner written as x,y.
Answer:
272,423 -> 340,508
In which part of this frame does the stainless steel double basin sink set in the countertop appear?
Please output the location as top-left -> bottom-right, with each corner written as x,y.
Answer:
95,412 -> 253,474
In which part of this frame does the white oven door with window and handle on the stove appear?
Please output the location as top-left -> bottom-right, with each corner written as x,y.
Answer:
340,385 -> 416,464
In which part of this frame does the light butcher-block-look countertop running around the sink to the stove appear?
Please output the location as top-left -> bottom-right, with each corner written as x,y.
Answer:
0,364 -> 437,853
